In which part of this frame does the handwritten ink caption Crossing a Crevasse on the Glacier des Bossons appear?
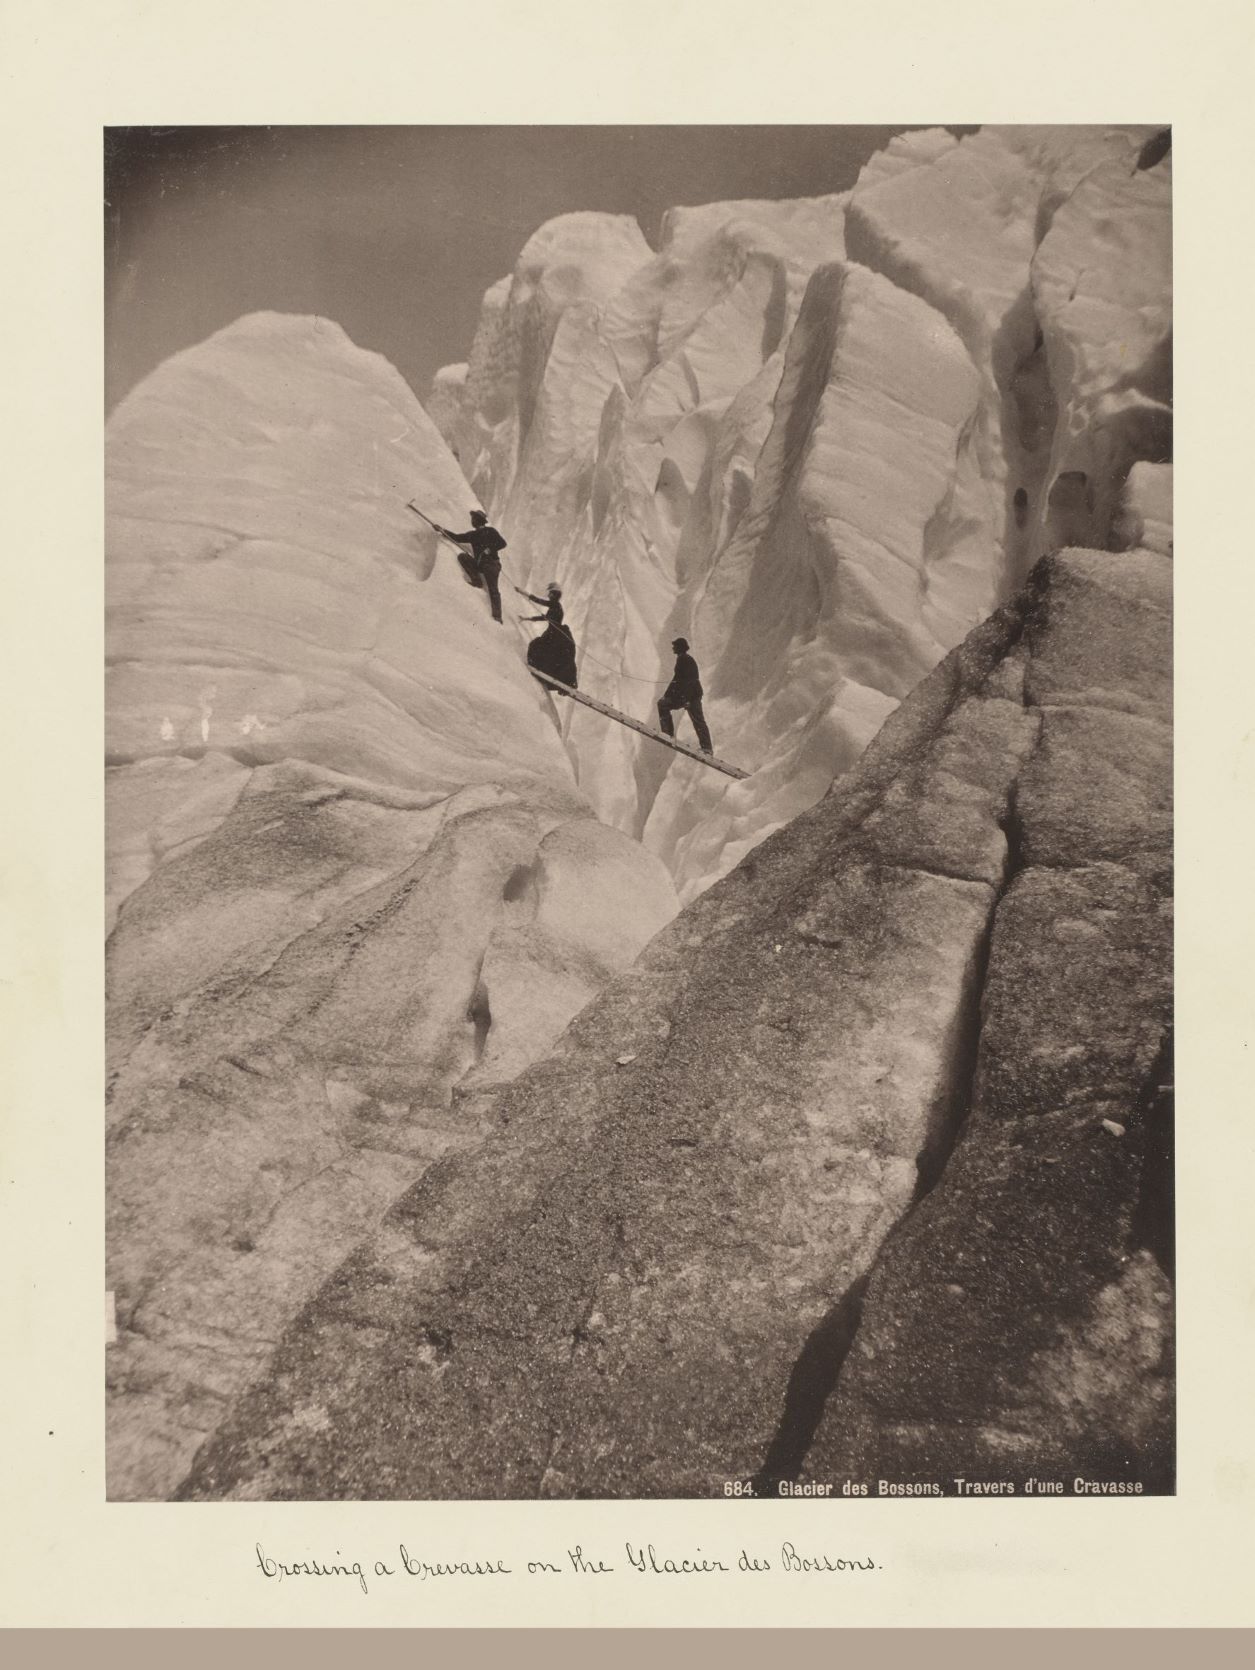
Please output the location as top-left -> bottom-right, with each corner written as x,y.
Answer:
254,1541 -> 882,1595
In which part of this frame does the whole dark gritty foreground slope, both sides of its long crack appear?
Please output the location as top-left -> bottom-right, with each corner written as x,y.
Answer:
180,551 -> 1170,1498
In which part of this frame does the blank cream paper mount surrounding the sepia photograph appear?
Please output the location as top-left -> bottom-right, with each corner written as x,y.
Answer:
0,0 -> 1255,1628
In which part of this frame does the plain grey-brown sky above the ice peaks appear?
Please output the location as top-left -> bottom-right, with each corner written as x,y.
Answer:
105,127 -> 969,407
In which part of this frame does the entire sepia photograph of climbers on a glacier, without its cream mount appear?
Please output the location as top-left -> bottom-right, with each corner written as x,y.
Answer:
105,112 -> 1186,1503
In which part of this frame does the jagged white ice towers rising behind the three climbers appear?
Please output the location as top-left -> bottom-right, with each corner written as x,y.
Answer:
429,127 -> 1170,898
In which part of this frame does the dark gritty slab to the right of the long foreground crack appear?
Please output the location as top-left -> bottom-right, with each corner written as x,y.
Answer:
807,553 -> 1173,1493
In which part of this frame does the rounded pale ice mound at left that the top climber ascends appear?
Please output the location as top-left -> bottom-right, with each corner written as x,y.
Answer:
107,314 -> 677,1496
